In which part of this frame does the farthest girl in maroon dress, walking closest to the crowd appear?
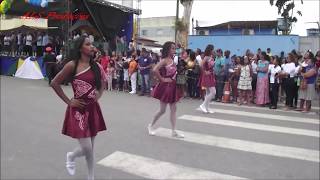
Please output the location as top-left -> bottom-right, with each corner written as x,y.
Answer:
200,44 -> 216,113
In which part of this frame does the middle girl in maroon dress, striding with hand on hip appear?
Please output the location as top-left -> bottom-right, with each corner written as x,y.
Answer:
148,42 -> 184,138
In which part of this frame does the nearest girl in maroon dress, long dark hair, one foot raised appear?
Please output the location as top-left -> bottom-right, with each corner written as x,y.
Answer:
51,36 -> 106,180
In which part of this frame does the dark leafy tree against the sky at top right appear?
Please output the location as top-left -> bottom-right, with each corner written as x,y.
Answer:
269,0 -> 303,35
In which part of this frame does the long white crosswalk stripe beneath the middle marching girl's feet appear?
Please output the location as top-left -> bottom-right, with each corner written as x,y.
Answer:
156,128 -> 319,162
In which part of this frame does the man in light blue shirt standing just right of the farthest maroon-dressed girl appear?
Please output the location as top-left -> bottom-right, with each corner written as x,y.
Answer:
214,49 -> 226,102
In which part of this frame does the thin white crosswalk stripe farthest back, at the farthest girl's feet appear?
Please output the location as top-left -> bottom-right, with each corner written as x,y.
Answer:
197,108 -> 320,124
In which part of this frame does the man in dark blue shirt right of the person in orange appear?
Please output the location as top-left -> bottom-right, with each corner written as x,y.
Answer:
138,48 -> 152,96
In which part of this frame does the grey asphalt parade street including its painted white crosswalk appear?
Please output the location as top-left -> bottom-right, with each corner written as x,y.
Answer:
1,76 -> 320,180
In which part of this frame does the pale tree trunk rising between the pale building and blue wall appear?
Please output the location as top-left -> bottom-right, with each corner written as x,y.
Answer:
175,0 -> 193,48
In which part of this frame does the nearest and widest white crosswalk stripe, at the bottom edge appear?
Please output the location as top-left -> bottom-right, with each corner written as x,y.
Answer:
98,151 -> 245,179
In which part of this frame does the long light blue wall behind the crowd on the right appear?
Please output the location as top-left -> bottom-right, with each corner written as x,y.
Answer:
188,35 -> 299,55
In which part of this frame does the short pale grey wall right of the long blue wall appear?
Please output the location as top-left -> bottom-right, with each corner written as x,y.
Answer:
299,36 -> 320,54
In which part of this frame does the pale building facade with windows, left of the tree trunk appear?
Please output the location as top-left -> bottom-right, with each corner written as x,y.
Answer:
140,16 -> 176,44
